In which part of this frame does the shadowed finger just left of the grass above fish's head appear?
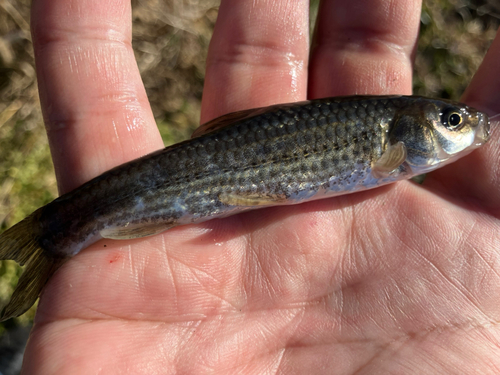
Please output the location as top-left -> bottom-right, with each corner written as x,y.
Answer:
309,0 -> 421,98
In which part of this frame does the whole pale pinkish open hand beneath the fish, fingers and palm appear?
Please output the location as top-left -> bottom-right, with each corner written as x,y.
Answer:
23,0 -> 500,374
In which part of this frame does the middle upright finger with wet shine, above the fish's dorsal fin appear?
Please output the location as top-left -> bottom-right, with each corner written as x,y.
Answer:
201,0 -> 309,123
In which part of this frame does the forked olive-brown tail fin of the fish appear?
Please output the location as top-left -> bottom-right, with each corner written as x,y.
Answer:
0,212 -> 66,322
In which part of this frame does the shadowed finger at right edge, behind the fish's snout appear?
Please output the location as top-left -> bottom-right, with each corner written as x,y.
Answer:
426,34 -> 500,217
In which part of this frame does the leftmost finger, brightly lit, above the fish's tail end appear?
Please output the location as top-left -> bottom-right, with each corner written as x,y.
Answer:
32,0 -> 162,193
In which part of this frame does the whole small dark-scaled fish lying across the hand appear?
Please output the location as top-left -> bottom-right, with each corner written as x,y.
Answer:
0,95 -> 490,321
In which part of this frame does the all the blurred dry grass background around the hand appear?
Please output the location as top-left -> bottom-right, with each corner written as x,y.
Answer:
0,0 -> 500,375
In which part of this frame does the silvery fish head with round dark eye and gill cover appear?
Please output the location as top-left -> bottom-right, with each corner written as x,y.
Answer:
389,98 -> 490,174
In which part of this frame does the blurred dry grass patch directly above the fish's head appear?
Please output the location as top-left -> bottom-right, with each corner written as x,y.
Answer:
413,0 -> 500,99
